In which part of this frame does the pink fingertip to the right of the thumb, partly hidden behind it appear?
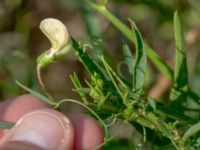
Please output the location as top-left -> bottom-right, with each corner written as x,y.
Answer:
68,113 -> 103,150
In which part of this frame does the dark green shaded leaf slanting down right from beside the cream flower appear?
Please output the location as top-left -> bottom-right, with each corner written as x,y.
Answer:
72,38 -> 106,80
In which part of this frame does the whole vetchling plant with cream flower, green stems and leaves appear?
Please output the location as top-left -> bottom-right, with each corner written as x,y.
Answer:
1,0 -> 200,150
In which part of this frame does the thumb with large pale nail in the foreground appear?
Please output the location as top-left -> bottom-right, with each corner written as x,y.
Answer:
0,109 -> 74,150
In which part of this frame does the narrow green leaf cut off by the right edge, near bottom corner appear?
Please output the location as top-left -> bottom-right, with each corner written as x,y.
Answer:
181,122 -> 200,144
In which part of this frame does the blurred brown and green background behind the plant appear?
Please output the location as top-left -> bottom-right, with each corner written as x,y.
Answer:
0,0 -> 200,149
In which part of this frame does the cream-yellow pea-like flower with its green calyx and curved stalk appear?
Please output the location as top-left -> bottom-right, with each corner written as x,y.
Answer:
37,18 -> 71,99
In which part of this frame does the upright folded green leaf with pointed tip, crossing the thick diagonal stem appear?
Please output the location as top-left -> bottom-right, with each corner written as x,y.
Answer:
131,21 -> 147,96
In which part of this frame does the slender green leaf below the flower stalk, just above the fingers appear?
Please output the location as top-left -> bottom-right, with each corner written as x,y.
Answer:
15,81 -> 56,106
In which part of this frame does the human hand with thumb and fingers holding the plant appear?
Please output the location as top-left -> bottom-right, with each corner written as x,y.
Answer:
0,95 -> 103,150
